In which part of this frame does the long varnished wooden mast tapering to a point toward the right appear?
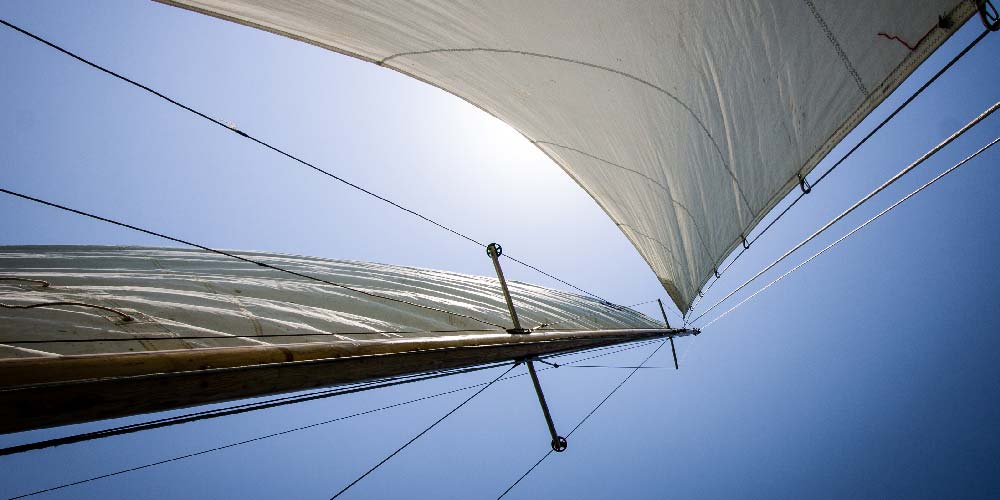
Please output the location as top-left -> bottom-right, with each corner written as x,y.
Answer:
0,329 -> 698,433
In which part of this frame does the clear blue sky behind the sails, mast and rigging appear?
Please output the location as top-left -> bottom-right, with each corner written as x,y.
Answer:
0,1 -> 1000,499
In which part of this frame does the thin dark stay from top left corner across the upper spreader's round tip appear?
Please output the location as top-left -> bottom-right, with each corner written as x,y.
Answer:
0,19 -> 614,304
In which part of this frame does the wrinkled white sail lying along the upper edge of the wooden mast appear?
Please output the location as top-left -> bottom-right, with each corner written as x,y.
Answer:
0,246 -> 662,359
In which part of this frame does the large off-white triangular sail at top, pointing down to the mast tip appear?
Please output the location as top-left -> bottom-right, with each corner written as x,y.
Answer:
160,0 -> 974,309
